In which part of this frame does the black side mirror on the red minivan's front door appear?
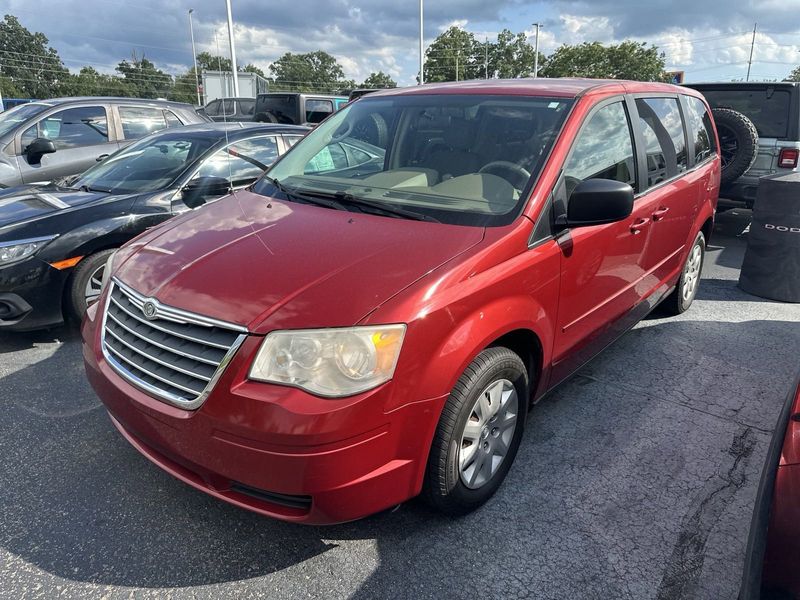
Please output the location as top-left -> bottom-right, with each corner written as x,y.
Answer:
556,179 -> 633,228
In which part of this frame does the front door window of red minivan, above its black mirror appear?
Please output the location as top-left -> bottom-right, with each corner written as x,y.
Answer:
564,102 -> 635,197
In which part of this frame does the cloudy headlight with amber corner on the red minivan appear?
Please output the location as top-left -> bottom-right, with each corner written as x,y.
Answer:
250,325 -> 406,398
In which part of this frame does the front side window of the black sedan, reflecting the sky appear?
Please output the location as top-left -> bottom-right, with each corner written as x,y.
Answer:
195,136 -> 278,186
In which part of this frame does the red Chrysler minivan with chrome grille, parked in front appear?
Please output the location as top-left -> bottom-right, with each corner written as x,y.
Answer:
83,79 -> 720,523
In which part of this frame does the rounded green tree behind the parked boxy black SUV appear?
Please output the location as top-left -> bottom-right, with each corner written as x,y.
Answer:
269,50 -> 346,92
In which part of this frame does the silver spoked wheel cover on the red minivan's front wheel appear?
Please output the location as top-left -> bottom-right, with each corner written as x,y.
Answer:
458,379 -> 519,490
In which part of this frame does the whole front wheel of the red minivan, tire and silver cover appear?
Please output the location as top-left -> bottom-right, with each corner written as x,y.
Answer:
423,347 -> 529,516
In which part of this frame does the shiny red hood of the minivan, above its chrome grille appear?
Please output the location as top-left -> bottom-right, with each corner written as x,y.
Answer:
115,191 -> 484,333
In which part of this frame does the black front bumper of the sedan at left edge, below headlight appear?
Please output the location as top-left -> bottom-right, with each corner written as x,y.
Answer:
0,257 -> 71,331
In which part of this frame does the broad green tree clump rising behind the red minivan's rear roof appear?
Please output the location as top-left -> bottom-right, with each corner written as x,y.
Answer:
539,41 -> 666,81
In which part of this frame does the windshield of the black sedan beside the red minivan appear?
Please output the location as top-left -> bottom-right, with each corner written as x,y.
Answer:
69,130 -> 219,194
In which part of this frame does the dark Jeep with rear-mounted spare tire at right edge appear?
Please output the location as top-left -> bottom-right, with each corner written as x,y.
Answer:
687,82 -> 800,208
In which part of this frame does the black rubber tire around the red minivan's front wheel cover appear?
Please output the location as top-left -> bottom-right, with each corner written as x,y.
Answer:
422,347 -> 530,516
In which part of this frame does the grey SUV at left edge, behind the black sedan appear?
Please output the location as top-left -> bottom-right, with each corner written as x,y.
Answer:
0,98 -> 208,187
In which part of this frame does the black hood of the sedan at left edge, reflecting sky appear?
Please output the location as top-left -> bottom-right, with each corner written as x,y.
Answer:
0,186 -> 117,228
